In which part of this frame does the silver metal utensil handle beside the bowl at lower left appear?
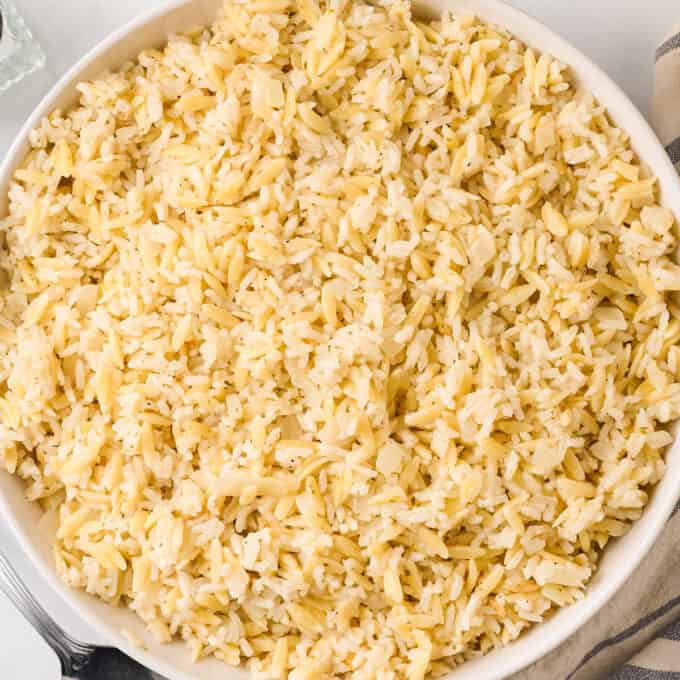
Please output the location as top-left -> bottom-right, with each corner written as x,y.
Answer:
0,552 -> 94,677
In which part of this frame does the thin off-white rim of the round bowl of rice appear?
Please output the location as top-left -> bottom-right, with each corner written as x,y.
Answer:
0,0 -> 680,680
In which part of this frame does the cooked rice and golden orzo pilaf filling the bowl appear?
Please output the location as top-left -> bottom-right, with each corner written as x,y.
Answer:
0,0 -> 680,680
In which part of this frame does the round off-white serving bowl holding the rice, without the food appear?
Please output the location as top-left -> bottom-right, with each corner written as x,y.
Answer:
0,0 -> 680,680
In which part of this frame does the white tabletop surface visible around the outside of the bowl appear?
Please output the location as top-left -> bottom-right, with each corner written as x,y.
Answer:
0,0 -> 680,680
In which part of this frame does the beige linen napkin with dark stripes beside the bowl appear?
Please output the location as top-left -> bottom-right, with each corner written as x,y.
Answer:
512,27 -> 680,680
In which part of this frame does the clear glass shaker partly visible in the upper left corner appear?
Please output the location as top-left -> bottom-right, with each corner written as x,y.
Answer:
0,0 -> 45,92
